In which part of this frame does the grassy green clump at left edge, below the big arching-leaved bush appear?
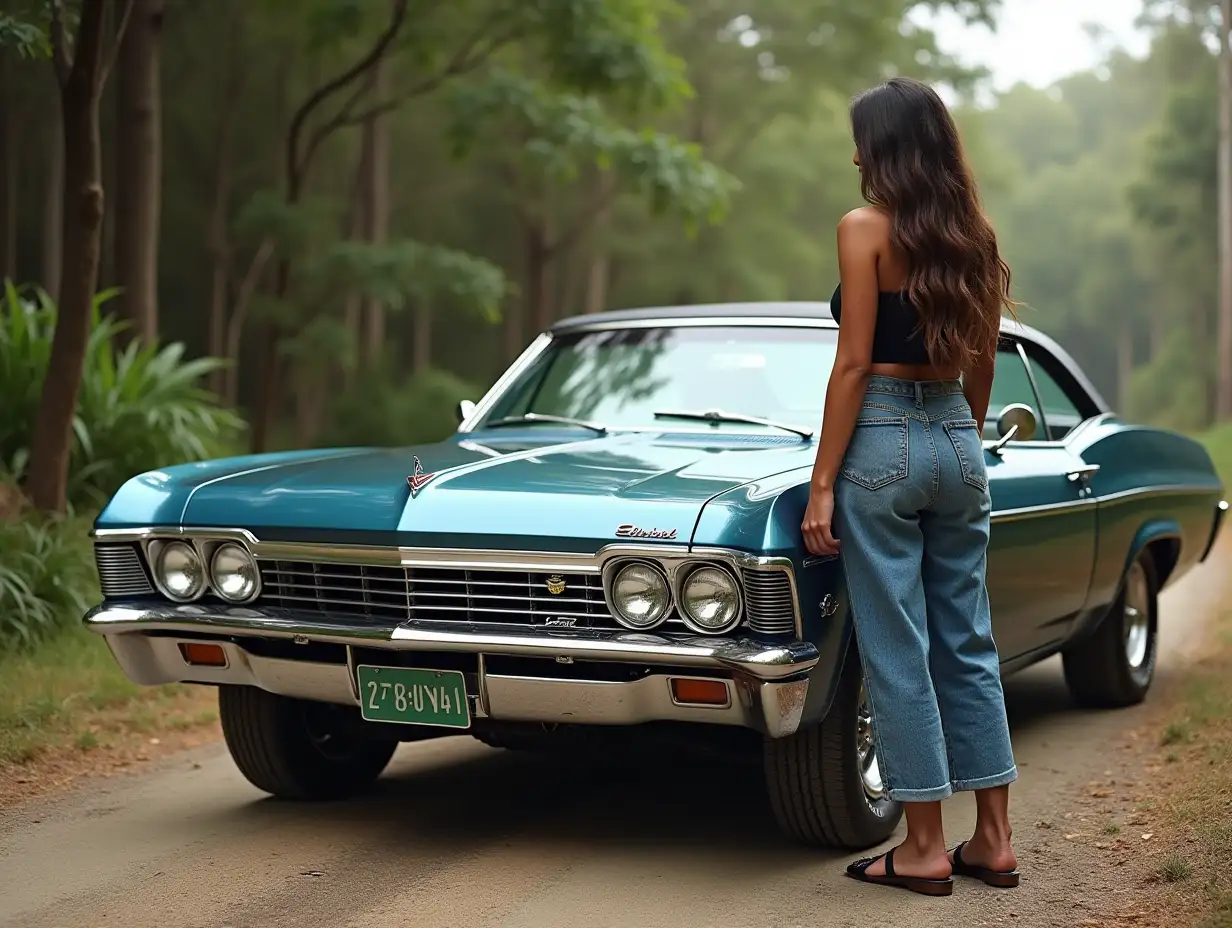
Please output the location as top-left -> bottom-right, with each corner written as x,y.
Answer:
0,502 -> 97,651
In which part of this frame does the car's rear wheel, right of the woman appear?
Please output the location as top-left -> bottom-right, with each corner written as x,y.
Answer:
1061,551 -> 1159,709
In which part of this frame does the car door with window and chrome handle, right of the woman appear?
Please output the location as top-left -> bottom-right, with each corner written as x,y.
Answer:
984,339 -> 1096,661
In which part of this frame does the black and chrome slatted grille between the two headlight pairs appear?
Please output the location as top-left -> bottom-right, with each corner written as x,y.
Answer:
260,561 -> 618,629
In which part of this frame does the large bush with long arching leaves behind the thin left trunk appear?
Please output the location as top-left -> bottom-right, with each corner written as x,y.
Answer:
0,285 -> 244,507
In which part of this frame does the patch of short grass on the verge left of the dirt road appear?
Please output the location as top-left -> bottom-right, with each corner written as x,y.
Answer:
0,626 -> 216,773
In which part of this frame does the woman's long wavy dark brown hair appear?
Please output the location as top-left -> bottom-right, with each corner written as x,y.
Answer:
851,78 -> 1015,371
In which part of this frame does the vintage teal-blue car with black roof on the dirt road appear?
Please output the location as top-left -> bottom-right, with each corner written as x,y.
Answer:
85,303 -> 1226,848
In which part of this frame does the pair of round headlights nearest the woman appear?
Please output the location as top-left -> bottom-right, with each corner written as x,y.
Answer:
610,561 -> 740,635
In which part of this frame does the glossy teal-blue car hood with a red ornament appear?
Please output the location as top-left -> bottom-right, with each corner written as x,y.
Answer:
171,434 -> 816,552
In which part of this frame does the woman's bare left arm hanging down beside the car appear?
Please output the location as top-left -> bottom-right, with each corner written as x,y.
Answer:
801,208 -> 886,555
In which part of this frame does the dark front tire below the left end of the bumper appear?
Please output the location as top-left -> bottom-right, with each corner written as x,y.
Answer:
218,686 -> 398,800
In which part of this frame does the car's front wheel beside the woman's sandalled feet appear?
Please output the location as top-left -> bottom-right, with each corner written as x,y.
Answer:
764,645 -> 903,850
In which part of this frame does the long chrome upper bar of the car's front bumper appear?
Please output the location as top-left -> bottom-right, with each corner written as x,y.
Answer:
84,604 -> 821,689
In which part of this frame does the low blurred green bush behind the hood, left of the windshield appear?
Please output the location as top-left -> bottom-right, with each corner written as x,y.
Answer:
318,366 -> 482,447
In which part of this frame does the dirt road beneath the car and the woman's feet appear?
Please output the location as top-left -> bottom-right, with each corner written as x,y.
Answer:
0,536 -> 1232,928
